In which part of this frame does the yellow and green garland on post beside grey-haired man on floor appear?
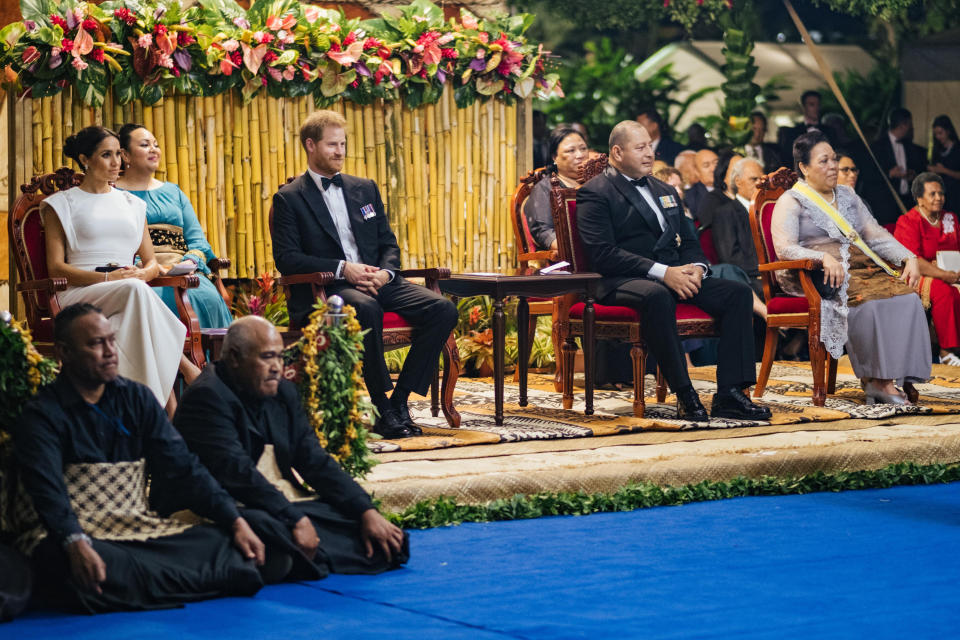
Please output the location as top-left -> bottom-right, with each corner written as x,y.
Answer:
284,302 -> 376,477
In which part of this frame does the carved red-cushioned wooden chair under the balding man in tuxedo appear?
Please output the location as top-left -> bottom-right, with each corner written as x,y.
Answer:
550,154 -> 718,418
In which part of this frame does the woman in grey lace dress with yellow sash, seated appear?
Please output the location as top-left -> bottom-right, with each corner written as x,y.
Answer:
771,132 -> 933,404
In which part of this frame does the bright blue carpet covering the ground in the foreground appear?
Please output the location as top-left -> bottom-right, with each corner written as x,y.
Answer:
0,483 -> 960,640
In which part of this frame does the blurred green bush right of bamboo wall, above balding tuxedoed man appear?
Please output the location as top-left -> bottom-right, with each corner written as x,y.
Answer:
537,38 -> 717,147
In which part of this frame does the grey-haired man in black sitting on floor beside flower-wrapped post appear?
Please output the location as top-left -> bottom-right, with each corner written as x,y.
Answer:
174,316 -> 409,580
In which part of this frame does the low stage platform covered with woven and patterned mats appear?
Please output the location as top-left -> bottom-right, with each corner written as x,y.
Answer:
364,360 -> 960,511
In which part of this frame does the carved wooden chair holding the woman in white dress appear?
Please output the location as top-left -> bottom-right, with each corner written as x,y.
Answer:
9,167 -> 206,368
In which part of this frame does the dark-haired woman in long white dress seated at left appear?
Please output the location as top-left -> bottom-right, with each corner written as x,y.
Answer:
41,126 -> 199,411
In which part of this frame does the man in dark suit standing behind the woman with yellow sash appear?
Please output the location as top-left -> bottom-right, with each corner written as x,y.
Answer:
860,109 -> 927,224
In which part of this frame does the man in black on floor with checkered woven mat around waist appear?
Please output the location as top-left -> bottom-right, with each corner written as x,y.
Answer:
14,303 -> 264,613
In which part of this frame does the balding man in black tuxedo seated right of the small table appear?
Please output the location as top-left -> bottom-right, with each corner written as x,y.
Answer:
577,120 -> 770,422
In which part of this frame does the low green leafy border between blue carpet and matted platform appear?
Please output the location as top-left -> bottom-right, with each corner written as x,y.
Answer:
387,462 -> 960,529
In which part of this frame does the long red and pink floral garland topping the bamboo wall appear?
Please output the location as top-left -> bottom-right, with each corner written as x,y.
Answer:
0,0 -> 562,108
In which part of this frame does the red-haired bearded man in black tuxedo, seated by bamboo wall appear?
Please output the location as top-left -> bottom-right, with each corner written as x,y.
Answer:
273,110 -> 457,438
